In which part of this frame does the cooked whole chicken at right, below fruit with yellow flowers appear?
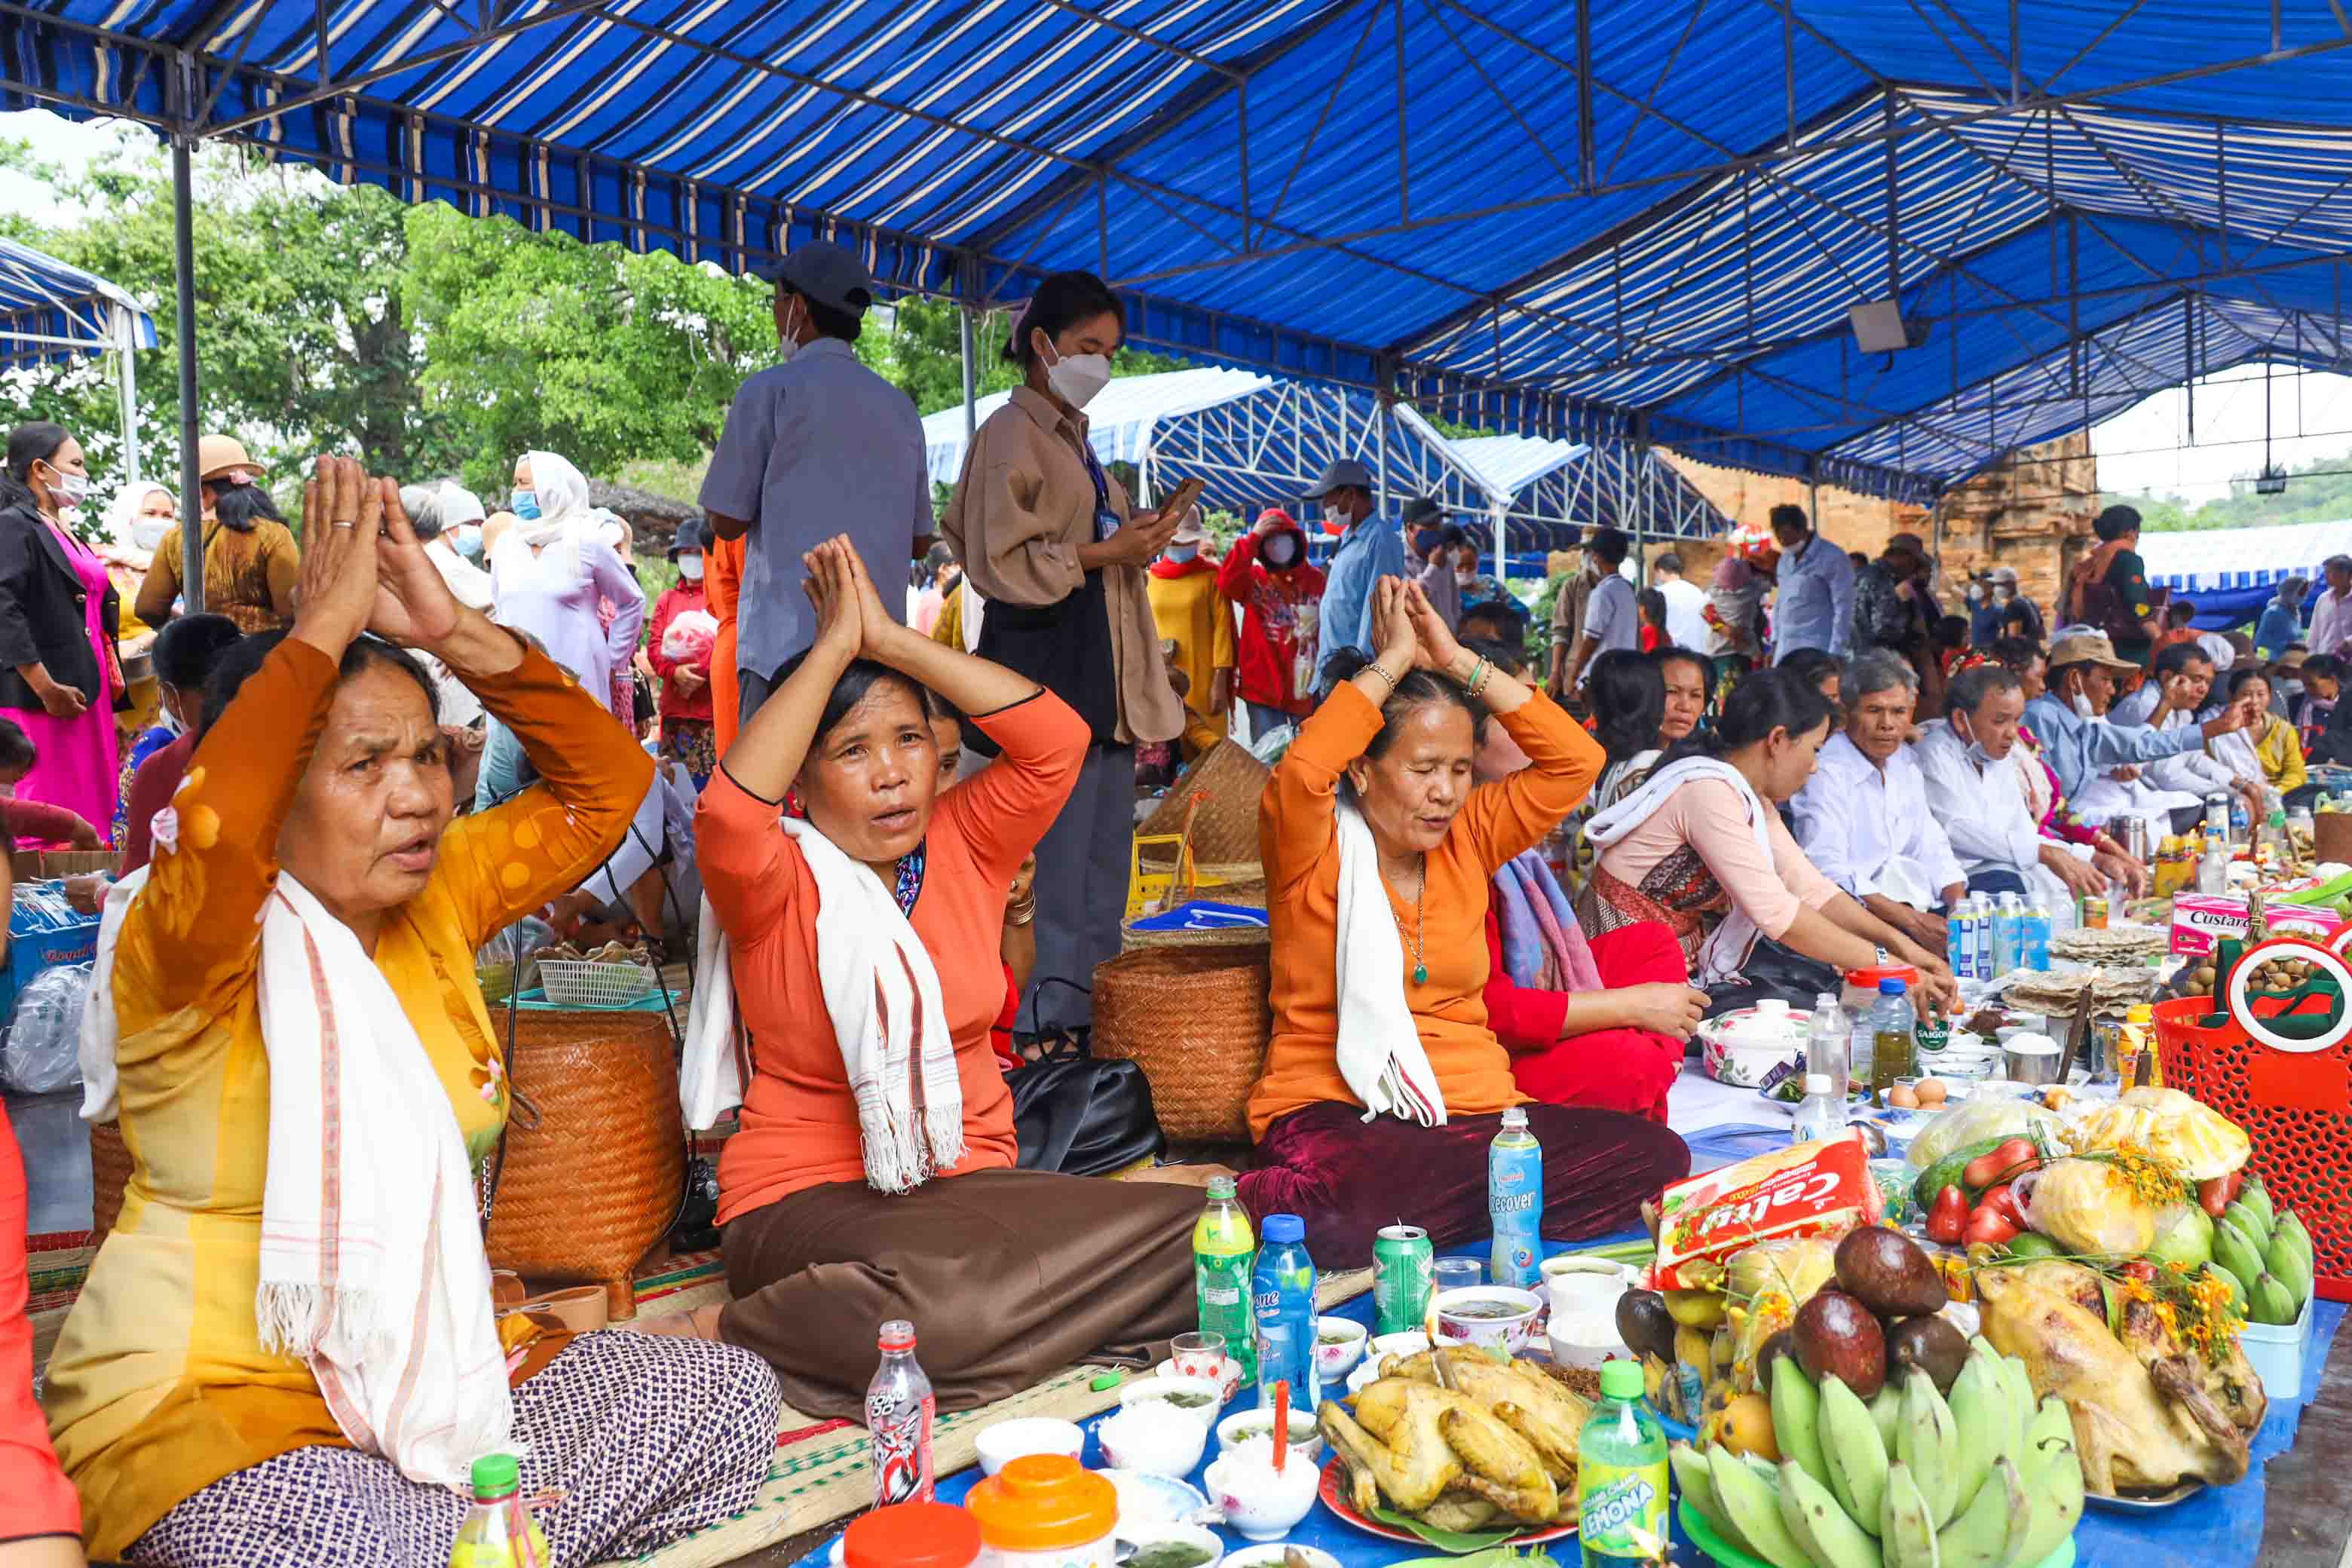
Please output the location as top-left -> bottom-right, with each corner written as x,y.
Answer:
1976,1263 -> 2265,1497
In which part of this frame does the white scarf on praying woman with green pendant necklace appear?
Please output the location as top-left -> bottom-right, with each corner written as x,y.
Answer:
1334,801 -> 1447,1126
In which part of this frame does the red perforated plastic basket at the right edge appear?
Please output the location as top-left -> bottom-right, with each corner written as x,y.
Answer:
2157,997 -> 2352,1300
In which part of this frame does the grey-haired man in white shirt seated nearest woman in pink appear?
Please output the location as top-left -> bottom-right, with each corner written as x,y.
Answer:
1790,651 -> 1968,952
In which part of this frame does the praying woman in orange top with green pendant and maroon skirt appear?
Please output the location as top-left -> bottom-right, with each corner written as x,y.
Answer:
1242,578 -> 1691,1260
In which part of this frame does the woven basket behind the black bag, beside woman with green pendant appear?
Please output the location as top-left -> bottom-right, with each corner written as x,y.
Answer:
1094,945 -> 1275,1143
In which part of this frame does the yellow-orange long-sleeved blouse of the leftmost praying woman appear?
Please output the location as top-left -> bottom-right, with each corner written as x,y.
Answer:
42,642 -> 654,1559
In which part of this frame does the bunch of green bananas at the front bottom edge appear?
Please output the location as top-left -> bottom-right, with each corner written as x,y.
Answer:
1670,1340 -> 2081,1568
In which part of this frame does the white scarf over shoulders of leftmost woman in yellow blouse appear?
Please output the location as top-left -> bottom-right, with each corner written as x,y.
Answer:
80,869 -> 515,1486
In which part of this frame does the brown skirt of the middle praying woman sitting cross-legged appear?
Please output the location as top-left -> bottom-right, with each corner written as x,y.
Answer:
720,1171 -> 1202,1417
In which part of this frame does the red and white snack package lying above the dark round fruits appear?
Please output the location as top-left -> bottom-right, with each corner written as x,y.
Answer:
1651,1133 -> 1884,1291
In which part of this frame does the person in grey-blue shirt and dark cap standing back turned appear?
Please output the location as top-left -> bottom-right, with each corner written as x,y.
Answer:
701,240 -> 932,724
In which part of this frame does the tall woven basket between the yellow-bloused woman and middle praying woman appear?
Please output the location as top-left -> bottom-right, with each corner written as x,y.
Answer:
489,1013 -> 687,1318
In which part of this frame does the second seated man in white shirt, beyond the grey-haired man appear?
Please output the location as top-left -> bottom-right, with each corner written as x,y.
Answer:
1909,666 -> 2133,900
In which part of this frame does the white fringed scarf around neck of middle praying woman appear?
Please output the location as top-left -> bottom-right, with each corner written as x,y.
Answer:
678,816 -> 964,1192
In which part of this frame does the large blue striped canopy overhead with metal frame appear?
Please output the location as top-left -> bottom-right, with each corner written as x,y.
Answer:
0,0 -> 2352,498
